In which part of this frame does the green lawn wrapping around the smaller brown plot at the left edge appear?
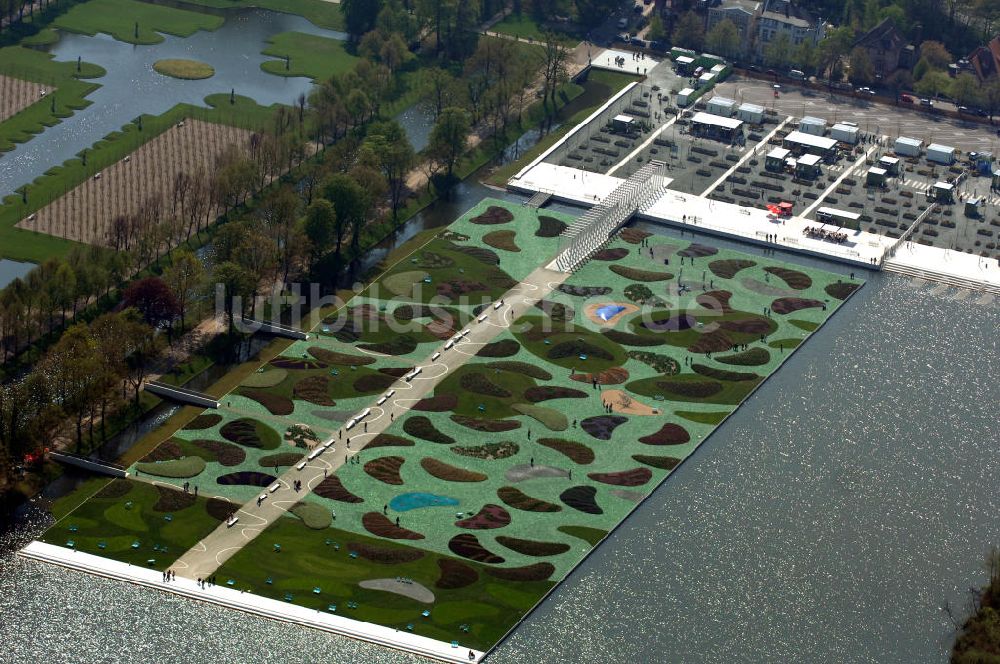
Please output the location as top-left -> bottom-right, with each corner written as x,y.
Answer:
0,46 -> 107,153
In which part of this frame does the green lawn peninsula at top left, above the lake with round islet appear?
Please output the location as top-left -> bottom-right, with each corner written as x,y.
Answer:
53,0 -> 224,44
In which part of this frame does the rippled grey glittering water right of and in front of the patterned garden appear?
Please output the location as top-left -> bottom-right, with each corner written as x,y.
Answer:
0,268 -> 1000,664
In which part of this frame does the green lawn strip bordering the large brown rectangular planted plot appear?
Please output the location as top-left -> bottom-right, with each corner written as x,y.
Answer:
0,94 -> 277,263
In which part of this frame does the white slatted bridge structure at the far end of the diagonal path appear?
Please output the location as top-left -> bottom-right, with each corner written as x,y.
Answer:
547,161 -> 666,272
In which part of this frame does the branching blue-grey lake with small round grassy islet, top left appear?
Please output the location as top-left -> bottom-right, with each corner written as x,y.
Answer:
0,10 -> 346,198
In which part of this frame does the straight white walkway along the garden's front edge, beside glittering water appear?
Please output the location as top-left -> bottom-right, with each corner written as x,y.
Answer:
19,541 -> 485,664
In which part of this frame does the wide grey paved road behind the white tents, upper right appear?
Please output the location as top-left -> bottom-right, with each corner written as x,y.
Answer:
715,75 -> 1000,154
